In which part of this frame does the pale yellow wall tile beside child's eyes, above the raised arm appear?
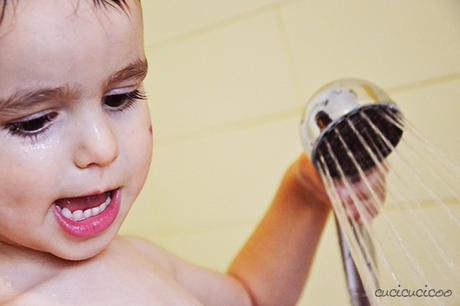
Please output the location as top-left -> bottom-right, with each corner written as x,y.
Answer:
146,12 -> 298,138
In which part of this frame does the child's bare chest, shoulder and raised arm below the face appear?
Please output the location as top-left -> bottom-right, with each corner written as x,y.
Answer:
0,155 -> 328,306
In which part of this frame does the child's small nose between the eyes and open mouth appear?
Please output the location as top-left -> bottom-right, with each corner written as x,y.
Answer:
74,113 -> 118,169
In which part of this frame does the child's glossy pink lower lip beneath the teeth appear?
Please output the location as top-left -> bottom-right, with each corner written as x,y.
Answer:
54,189 -> 121,238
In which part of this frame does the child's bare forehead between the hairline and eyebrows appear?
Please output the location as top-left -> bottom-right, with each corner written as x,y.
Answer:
0,0 -> 144,97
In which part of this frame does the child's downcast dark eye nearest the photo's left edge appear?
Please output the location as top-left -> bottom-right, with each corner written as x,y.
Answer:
5,112 -> 58,139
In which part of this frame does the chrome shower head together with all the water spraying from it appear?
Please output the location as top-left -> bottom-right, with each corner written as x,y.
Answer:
300,79 -> 460,306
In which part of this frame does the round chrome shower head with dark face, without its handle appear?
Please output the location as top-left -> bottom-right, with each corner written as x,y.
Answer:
300,79 -> 403,178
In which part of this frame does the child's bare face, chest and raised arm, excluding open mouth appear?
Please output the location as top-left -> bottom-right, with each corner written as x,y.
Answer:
0,0 -> 330,306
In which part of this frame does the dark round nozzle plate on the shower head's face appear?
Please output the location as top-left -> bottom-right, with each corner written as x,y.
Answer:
312,104 -> 403,178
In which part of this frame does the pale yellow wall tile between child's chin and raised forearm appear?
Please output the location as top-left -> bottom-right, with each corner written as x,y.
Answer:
125,118 -> 301,232
